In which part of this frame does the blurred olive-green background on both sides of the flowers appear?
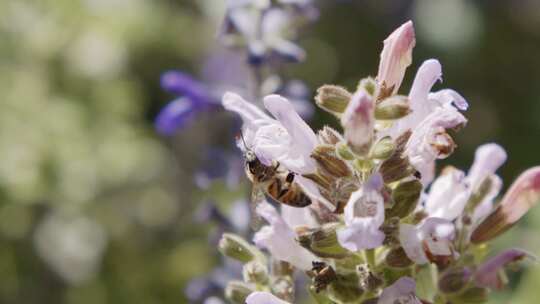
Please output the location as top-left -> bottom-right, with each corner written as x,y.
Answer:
0,0 -> 540,304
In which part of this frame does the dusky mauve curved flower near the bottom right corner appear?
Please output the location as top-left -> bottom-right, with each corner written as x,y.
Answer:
474,248 -> 531,289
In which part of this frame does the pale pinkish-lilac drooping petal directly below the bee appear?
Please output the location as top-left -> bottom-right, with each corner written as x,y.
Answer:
253,202 -> 317,270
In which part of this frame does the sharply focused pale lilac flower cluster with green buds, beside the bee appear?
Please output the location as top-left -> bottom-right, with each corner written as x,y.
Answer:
219,21 -> 540,304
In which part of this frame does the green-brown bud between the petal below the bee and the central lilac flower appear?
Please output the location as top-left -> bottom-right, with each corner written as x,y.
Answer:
298,223 -> 349,259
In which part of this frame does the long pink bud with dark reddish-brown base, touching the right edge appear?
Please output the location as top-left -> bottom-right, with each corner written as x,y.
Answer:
471,166 -> 540,244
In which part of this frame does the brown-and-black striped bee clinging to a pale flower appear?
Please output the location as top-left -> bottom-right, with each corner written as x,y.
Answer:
242,137 -> 311,208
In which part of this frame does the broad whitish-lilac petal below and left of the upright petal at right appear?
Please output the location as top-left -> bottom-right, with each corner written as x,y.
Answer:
425,167 -> 470,221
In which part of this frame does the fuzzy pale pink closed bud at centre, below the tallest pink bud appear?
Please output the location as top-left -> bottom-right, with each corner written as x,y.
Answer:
341,90 -> 375,155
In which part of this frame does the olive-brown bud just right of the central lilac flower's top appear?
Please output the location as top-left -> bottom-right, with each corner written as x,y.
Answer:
387,179 -> 423,218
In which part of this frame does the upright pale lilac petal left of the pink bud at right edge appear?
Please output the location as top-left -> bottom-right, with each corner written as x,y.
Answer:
467,143 -> 507,189
